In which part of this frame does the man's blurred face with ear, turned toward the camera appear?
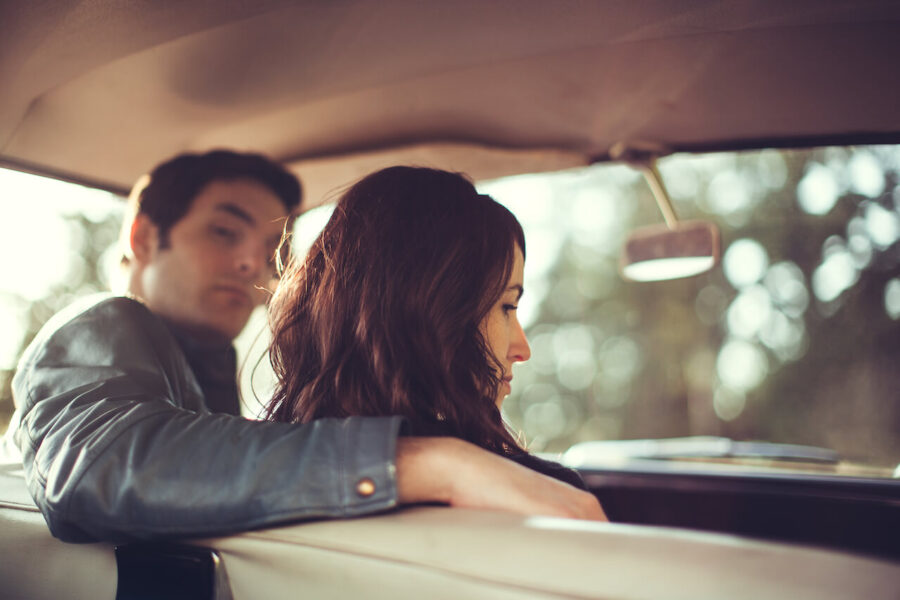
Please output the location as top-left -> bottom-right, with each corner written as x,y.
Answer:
131,179 -> 287,340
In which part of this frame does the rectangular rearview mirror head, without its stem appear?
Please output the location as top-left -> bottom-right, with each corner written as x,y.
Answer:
620,221 -> 719,281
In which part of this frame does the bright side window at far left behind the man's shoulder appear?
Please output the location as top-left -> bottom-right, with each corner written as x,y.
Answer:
0,169 -> 125,430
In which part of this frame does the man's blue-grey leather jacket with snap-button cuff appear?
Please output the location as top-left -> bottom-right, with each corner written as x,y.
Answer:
7,296 -> 401,542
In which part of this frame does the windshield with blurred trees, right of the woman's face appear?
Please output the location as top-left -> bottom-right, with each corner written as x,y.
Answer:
479,146 -> 900,475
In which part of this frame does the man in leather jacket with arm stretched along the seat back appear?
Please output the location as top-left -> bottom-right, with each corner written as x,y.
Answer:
10,151 -> 604,542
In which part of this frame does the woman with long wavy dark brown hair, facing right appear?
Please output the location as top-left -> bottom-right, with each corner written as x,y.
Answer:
266,167 -> 584,488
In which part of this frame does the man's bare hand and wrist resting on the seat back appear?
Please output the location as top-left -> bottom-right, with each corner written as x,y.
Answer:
397,437 -> 608,521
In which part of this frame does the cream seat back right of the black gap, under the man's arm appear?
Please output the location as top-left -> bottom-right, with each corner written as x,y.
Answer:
205,507 -> 900,600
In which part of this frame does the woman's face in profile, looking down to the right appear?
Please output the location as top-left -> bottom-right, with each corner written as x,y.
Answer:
481,245 -> 531,408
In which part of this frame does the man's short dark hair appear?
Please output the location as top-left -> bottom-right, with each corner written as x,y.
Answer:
132,150 -> 302,248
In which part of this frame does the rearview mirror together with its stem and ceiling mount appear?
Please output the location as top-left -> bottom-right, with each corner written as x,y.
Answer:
609,142 -> 720,281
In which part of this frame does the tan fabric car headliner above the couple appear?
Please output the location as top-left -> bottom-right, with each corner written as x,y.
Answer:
0,0 -> 900,204
